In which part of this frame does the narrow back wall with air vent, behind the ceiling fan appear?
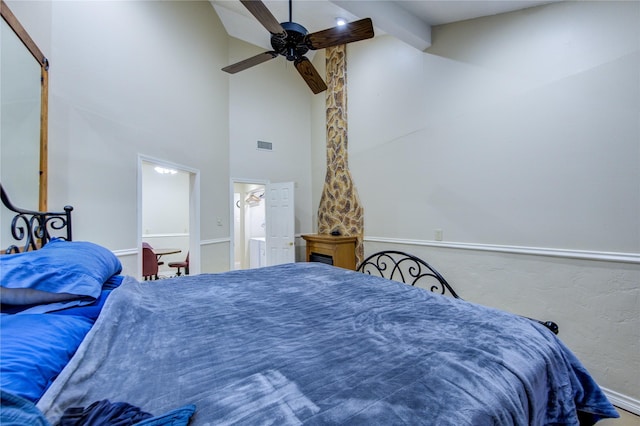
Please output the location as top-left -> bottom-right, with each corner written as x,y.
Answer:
229,38 -> 316,253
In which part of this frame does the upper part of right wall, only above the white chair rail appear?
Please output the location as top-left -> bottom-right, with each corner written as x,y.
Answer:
349,2 -> 640,253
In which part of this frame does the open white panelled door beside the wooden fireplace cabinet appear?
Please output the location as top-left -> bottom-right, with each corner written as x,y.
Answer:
265,182 -> 296,265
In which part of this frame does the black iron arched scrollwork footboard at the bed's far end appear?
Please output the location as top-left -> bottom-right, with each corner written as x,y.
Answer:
357,250 -> 559,334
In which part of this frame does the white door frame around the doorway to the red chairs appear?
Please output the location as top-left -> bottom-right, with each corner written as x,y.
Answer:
136,154 -> 201,277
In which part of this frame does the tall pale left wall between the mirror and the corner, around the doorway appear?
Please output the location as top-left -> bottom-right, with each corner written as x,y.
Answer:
8,0 -> 229,275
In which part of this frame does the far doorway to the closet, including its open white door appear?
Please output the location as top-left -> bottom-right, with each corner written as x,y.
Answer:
231,179 -> 295,269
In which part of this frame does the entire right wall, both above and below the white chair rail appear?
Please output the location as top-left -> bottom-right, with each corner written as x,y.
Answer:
313,2 -> 640,409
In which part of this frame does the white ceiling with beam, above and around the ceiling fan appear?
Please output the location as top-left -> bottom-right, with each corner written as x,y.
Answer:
210,0 -> 559,50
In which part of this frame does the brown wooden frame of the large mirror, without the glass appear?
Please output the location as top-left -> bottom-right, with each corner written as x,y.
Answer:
0,0 -> 49,211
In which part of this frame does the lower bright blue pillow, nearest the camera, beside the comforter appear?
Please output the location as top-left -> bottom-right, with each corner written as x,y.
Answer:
0,314 -> 93,402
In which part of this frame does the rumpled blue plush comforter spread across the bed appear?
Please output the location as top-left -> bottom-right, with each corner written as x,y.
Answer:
38,263 -> 617,426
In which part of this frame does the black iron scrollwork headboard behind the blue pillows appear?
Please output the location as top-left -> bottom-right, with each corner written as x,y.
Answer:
0,184 -> 73,254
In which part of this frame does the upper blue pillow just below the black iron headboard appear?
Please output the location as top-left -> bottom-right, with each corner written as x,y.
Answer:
0,239 -> 122,305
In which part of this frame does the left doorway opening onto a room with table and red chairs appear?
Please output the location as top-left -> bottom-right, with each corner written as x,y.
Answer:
138,156 -> 200,277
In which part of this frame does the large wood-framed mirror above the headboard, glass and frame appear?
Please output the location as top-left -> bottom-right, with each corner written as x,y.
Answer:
0,0 -> 49,211
